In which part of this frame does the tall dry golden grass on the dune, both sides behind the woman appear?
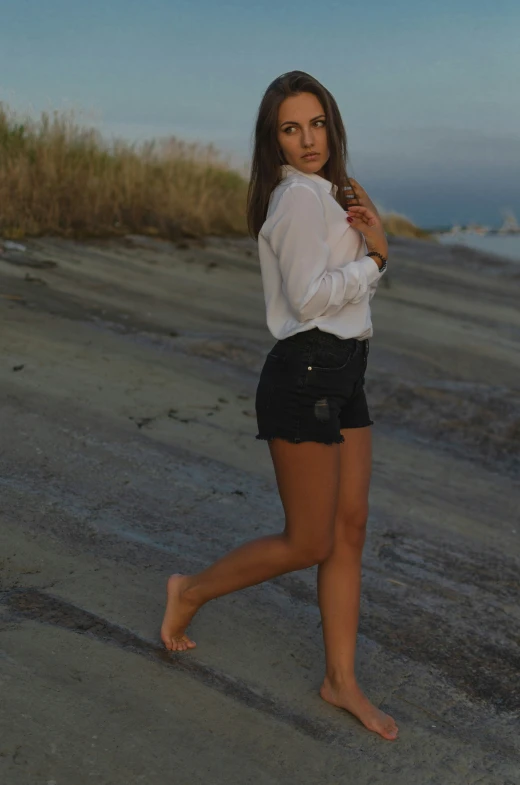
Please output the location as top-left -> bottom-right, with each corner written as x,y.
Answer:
0,103 -> 424,239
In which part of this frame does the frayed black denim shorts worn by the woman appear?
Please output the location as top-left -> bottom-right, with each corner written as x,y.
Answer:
255,327 -> 373,444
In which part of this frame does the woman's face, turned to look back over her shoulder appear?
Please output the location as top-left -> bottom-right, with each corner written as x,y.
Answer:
277,93 -> 329,176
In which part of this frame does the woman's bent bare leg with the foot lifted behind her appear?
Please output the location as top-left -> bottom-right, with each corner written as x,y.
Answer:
161,439 -> 340,651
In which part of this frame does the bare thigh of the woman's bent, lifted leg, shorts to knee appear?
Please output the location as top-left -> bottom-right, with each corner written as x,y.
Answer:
269,439 -> 340,558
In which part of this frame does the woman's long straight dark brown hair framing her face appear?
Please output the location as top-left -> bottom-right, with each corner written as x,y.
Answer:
247,71 -> 350,240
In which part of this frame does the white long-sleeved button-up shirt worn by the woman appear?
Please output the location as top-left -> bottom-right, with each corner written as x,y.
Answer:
258,164 -> 384,340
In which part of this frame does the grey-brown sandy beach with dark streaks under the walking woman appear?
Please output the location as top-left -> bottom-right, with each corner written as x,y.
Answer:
0,236 -> 520,785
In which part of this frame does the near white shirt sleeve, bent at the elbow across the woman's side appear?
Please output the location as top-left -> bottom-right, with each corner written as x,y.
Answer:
268,183 -> 380,322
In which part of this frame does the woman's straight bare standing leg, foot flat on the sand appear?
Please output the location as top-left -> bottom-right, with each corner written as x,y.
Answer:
318,427 -> 397,739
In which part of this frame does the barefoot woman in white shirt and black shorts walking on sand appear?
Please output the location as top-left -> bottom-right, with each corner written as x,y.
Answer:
161,71 -> 397,739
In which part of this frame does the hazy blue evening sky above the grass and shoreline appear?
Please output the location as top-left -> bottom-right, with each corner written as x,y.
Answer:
0,0 -> 520,227
